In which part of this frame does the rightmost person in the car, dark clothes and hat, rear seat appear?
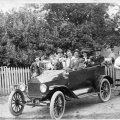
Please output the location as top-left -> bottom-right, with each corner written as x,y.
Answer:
90,48 -> 104,66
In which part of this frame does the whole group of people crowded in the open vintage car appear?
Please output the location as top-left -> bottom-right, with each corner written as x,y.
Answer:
30,48 -> 104,76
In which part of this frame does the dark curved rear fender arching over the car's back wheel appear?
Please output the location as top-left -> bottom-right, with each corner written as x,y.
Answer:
95,75 -> 113,92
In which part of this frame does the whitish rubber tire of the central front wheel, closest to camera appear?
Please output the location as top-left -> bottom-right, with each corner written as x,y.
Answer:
50,91 -> 66,120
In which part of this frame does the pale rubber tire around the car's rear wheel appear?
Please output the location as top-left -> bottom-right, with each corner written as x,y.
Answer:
98,78 -> 111,102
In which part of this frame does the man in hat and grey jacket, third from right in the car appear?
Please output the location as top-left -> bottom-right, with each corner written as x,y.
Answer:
71,49 -> 85,70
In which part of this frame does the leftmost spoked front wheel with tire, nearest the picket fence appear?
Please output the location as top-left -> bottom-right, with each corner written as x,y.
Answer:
9,90 -> 24,116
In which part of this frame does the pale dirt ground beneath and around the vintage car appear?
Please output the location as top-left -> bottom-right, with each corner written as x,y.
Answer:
0,90 -> 120,120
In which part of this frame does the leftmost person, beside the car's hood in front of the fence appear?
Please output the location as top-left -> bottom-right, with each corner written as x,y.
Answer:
30,55 -> 44,77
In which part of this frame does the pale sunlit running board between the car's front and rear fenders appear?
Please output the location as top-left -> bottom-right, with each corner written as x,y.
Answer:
73,87 -> 94,96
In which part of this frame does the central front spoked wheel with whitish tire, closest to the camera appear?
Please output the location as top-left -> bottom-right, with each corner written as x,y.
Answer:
50,91 -> 65,120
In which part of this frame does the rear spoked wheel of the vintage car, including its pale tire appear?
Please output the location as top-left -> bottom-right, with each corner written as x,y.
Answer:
98,78 -> 111,102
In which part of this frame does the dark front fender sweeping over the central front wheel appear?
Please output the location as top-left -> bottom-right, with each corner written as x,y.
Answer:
49,85 -> 78,98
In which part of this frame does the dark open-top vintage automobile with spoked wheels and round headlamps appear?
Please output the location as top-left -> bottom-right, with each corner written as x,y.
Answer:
9,65 -> 113,119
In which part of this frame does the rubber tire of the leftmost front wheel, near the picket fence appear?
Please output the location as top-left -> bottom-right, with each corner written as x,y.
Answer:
8,90 -> 25,116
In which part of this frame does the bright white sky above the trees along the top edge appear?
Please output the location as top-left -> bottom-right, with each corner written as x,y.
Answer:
0,0 -> 120,15
